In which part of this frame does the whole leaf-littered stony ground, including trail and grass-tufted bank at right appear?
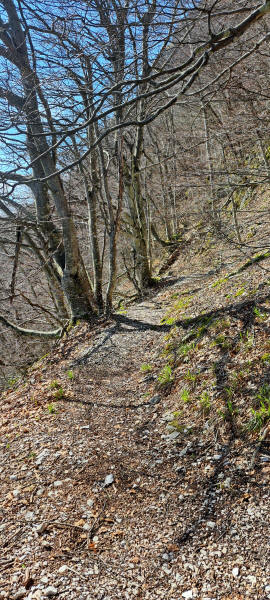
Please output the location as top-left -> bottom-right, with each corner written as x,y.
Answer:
0,239 -> 270,600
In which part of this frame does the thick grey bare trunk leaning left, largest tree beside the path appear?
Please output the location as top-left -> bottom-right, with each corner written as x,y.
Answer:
3,0 -> 95,320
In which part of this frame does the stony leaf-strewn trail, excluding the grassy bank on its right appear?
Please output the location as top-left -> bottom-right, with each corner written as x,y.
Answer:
0,274 -> 270,600
